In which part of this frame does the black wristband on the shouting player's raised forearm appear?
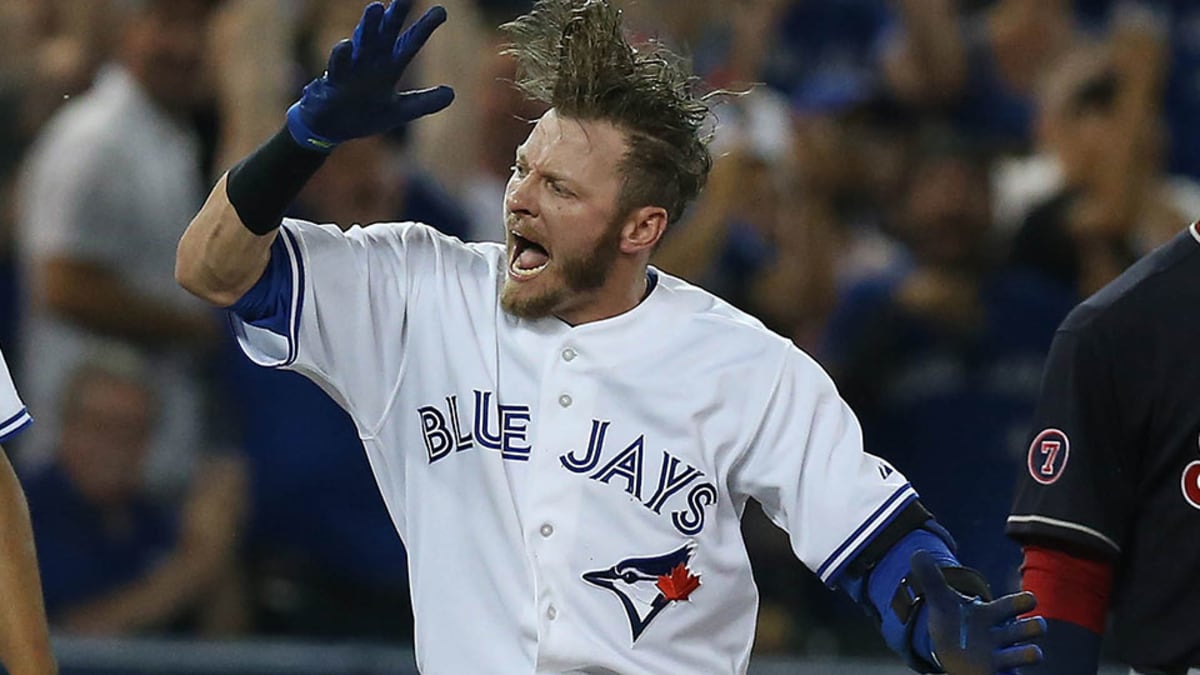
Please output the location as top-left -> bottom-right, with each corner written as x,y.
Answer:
226,127 -> 328,235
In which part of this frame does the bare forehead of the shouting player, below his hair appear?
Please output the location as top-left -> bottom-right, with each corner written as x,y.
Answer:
517,110 -> 626,178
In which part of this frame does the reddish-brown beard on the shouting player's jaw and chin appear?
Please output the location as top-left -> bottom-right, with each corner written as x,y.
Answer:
500,220 -> 622,318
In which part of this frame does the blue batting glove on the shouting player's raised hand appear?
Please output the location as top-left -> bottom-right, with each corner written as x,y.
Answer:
288,0 -> 454,153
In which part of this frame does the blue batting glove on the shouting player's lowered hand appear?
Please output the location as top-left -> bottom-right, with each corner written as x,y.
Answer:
912,551 -> 1046,675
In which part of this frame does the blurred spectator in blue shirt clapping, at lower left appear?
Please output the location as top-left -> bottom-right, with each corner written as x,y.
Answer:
25,350 -> 245,635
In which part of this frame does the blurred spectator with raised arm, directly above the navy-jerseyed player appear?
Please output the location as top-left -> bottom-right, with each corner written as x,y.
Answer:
1012,19 -> 1200,297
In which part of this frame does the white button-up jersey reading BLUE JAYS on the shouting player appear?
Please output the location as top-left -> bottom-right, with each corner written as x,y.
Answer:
234,220 -> 916,674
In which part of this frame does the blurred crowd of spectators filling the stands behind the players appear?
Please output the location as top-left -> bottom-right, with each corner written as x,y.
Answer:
0,0 -> 1200,653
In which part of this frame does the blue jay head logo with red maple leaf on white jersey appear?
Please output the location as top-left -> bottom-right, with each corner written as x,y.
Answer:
583,543 -> 700,643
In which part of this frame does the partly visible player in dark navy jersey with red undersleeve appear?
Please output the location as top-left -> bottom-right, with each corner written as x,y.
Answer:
1008,225 -> 1200,675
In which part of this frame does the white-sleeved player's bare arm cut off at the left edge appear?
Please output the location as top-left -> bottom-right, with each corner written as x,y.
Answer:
0,343 -> 58,675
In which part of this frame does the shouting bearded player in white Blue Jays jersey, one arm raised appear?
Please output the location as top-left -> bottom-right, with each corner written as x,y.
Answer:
176,0 -> 1043,675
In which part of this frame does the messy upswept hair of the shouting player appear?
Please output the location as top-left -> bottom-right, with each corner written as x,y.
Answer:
500,0 -> 713,222
